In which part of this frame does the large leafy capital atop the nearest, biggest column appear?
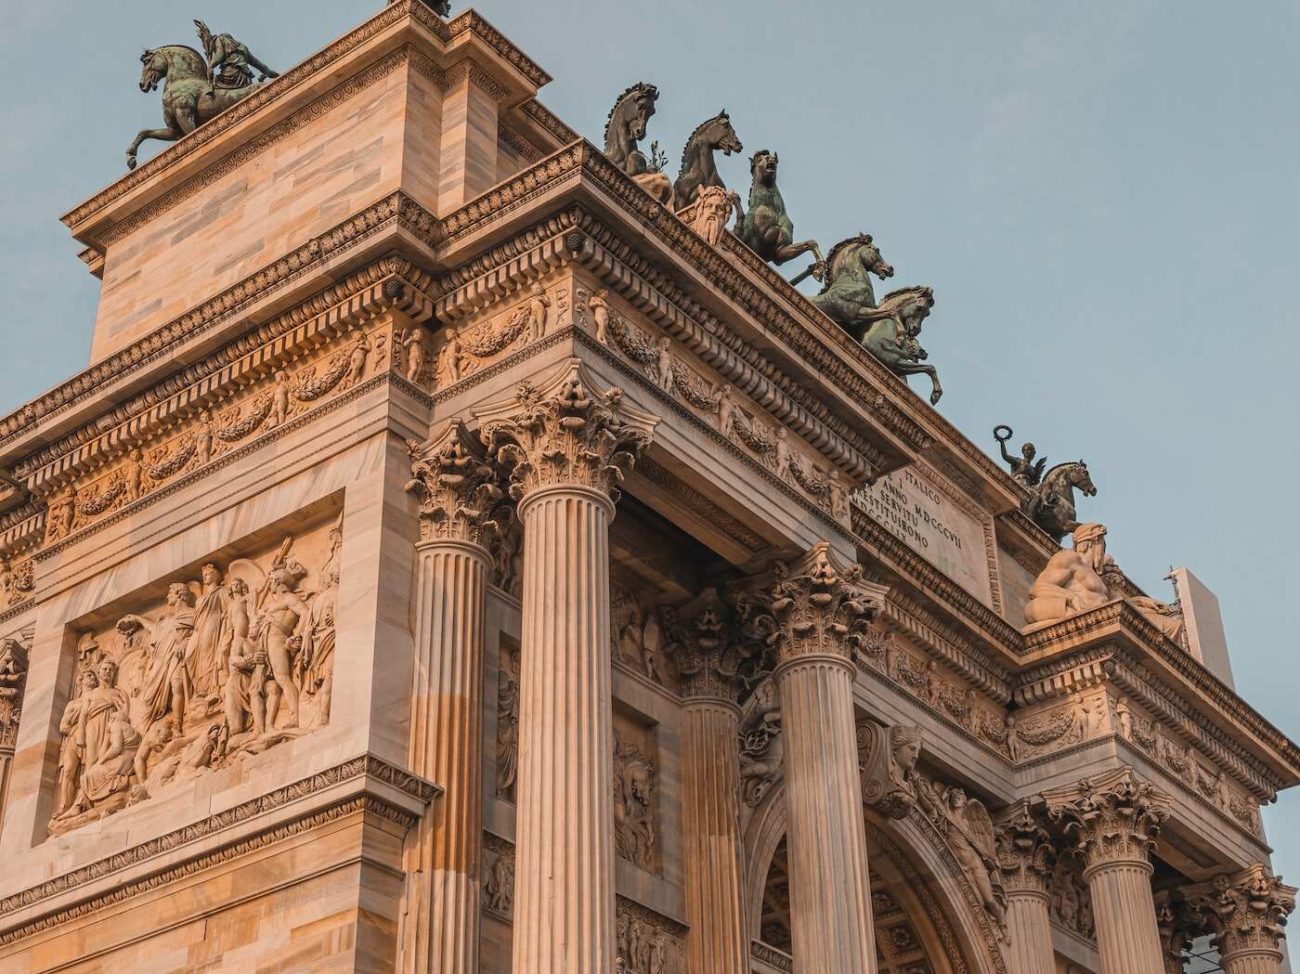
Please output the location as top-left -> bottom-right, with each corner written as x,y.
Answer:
476,359 -> 659,501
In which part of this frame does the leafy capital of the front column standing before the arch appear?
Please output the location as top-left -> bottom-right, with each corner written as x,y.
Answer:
736,541 -> 888,663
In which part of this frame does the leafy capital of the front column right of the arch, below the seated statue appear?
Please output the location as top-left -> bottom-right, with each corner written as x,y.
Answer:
1043,767 -> 1173,869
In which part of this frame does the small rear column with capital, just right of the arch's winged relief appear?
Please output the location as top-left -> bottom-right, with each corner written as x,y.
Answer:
997,804 -> 1056,974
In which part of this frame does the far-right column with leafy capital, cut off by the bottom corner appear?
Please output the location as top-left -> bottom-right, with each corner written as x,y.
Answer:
1191,866 -> 1296,974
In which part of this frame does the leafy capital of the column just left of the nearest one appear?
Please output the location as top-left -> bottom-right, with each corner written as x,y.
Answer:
406,420 -> 504,547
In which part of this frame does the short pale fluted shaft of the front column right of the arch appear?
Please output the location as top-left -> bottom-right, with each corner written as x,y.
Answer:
1083,860 -> 1165,974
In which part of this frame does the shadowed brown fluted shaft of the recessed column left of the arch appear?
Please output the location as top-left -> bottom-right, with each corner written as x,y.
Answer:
681,697 -> 750,974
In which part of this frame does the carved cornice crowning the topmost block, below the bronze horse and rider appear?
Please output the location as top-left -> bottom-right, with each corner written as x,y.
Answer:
62,0 -> 546,251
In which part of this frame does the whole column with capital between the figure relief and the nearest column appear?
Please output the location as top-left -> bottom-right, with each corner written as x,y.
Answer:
399,423 -> 503,974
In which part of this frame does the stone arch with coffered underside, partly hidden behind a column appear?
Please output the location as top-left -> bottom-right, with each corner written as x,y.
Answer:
744,782 -> 1006,974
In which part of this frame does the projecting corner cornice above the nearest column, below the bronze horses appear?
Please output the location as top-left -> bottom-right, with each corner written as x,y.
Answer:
426,143 -> 946,473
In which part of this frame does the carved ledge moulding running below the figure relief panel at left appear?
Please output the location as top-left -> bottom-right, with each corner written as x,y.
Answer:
0,754 -> 441,944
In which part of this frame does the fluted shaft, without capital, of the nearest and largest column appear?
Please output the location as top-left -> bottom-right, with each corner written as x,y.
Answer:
512,486 -> 616,974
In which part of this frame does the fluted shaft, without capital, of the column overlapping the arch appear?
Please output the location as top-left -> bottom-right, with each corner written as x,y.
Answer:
776,655 -> 876,974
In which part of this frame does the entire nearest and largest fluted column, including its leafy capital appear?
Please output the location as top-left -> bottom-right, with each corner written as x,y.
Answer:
478,362 -> 658,974
